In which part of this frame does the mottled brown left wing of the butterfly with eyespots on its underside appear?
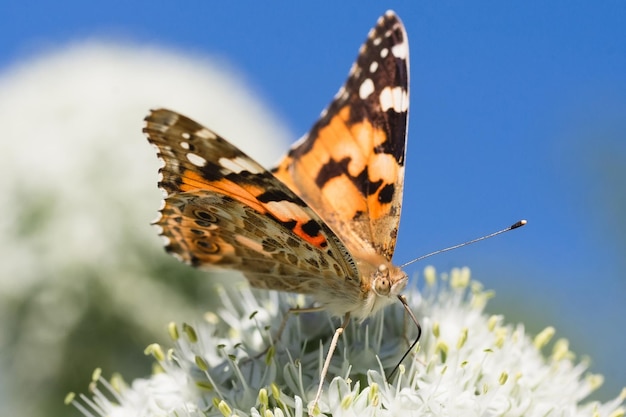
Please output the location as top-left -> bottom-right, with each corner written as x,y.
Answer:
144,109 -> 359,293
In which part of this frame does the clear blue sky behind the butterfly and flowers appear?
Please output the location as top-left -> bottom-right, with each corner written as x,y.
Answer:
0,0 -> 626,396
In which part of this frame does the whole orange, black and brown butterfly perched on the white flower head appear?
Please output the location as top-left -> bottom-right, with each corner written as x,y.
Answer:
144,11 -> 419,412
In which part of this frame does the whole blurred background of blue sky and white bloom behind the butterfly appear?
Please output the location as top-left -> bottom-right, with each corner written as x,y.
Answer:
0,0 -> 626,416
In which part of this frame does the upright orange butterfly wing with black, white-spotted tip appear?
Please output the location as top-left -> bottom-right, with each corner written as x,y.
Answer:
272,12 -> 409,261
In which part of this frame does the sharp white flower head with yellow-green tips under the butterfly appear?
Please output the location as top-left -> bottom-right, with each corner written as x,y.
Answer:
68,268 -> 626,417
